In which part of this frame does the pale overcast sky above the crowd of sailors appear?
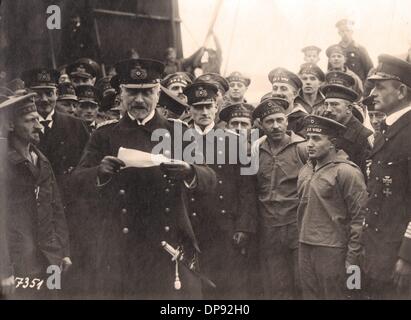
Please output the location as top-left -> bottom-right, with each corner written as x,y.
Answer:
179,0 -> 411,102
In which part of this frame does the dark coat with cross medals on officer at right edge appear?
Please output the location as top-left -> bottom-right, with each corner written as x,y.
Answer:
363,111 -> 411,298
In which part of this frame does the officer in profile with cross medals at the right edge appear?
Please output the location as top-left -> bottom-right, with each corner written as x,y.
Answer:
363,55 -> 411,299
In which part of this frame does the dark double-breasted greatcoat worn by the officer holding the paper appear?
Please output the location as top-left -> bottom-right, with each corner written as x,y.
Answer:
74,111 -> 216,299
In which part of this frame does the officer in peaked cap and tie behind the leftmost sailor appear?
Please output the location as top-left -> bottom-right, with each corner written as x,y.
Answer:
22,68 -> 89,298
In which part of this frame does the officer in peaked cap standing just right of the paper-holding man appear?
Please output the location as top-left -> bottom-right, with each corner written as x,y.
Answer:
184,82 -> 256,299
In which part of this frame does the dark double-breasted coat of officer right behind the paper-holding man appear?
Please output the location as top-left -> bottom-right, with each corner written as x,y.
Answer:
189,126 -> 257,299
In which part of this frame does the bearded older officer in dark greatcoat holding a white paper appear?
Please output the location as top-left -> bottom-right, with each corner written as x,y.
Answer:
75,59 -> 216,299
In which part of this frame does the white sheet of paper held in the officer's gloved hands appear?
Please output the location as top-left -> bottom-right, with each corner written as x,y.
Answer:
117,147 -> 172,168
